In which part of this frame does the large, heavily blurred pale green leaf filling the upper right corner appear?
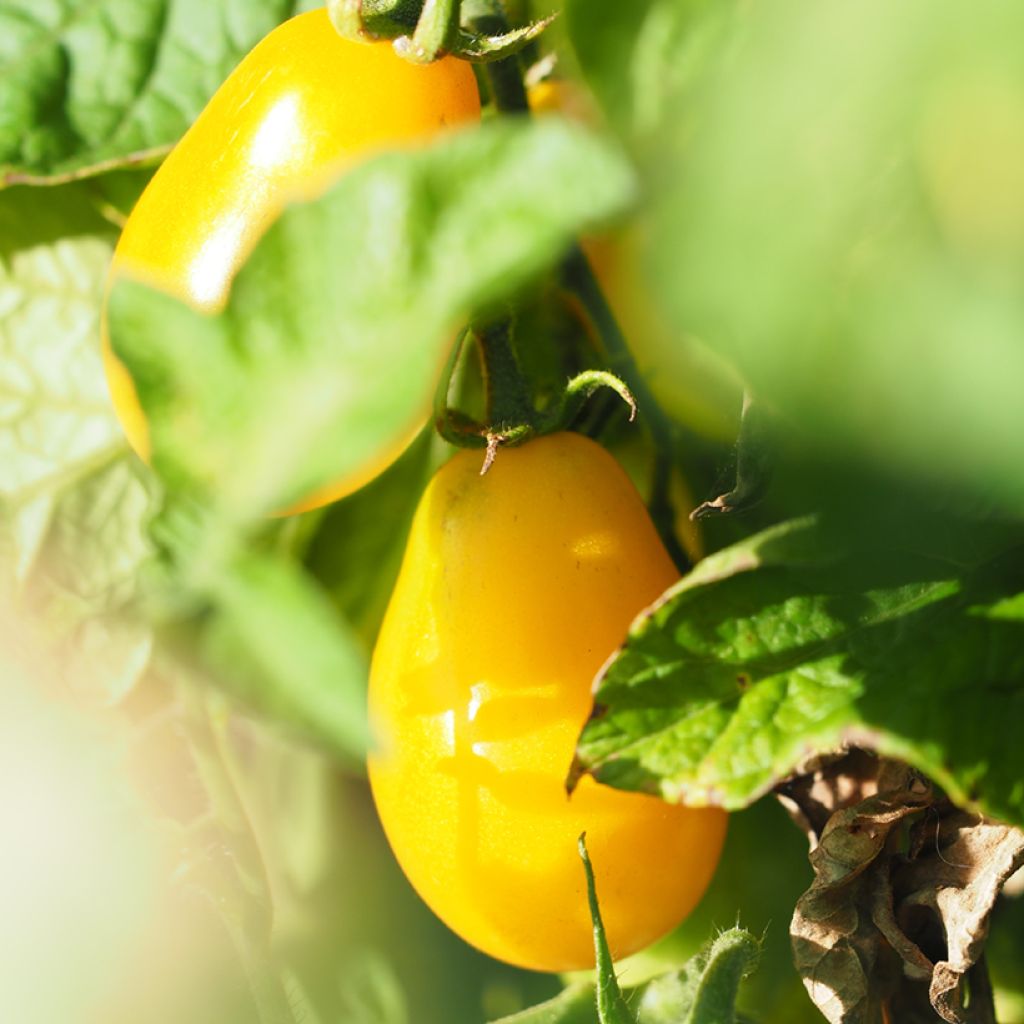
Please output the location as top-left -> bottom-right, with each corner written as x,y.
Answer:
638,0 -> 1024,511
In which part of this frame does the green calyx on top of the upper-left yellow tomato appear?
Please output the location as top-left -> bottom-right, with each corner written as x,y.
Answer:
327,0 -> 556,65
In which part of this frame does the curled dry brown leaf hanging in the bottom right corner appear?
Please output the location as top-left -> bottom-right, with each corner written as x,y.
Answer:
779,751 -> 1024,1024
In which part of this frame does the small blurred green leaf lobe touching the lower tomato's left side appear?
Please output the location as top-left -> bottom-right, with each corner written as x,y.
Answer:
200,553 -> 368,763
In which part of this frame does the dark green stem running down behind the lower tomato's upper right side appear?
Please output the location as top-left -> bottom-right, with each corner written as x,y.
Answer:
562,246 -> 691,572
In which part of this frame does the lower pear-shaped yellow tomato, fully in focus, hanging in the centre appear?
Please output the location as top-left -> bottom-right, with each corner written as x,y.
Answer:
370,433 -> 726,971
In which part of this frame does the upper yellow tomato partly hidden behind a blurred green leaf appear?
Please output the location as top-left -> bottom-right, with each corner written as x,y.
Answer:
103,8 -> 480,508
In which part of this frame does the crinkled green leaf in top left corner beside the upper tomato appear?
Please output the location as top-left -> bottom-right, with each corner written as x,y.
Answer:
0,0 -> 297,186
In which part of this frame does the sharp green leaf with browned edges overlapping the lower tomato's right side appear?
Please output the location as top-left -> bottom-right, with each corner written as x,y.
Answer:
579,520 -> 1024,821
